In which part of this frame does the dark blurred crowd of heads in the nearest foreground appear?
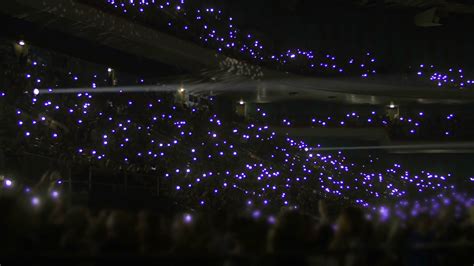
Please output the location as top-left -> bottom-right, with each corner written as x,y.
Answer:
0,188 -> 474,265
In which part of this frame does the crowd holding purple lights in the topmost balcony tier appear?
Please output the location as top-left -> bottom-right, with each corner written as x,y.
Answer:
81,0 -> 474,89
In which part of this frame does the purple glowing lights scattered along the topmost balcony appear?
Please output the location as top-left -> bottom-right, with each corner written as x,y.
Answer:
104,0 -> 474,89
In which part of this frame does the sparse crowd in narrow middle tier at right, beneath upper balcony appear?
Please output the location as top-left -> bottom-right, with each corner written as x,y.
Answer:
254,106 -> 474,141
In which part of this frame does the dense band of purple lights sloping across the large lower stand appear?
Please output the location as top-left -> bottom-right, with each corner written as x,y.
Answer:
4,51 -> 473,220
